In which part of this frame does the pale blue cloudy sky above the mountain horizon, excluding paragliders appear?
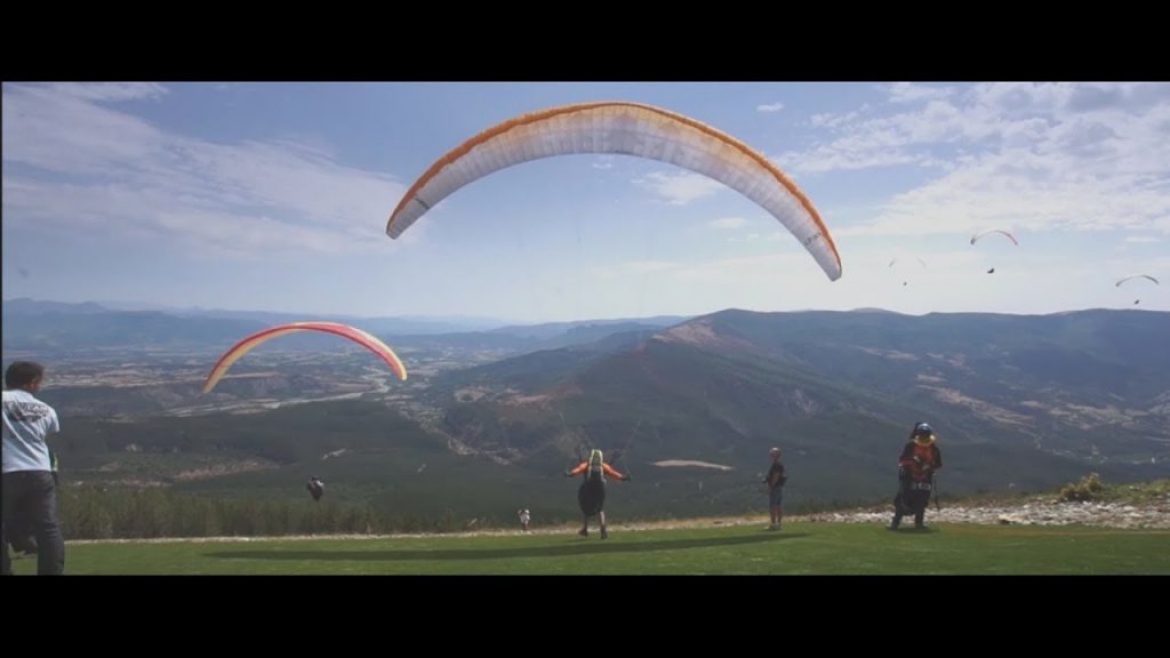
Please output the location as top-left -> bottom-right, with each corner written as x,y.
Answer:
2,83 -> 1170,322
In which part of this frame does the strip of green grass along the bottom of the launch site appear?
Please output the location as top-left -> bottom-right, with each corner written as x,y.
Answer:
14,522 -> 1170,575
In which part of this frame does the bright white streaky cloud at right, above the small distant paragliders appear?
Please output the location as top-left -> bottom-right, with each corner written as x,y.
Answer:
777,83 -> 1170,235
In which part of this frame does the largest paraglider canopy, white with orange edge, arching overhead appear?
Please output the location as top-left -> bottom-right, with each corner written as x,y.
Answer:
386,102 -> 841,281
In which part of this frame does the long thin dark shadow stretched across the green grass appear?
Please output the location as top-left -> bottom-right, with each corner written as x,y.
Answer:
205,526 -> 807,562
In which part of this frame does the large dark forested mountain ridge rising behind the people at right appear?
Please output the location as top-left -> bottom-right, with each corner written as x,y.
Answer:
432,310 -> 1170,494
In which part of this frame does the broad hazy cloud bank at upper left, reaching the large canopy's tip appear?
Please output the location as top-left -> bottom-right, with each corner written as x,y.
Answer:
4,85 -> 405,253
